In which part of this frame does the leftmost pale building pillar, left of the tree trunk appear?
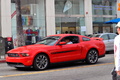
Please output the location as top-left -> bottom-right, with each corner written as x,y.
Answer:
1,0 -> 12,37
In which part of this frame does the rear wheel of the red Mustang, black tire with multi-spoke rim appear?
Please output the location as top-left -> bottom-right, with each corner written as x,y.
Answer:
86,49 -> 98,64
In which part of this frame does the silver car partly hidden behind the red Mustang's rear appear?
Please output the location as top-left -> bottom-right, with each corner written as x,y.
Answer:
92,33 -> 117,51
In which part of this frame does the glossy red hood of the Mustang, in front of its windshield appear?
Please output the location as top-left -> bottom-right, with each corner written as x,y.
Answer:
7,44 -> 50,53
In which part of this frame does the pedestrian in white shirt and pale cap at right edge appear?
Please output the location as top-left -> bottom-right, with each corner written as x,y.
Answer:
112,22 -> 120,80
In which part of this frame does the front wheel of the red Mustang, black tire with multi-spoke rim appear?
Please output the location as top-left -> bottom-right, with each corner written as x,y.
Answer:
33,54 -> 49,70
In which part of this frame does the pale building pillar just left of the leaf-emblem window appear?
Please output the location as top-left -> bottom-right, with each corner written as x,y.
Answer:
45,0 -> 55,35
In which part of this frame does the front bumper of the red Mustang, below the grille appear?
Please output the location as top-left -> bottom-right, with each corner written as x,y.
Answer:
6,57 -> 33,67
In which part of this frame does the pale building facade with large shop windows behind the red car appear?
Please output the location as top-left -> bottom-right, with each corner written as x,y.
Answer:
0,0 -> 120,43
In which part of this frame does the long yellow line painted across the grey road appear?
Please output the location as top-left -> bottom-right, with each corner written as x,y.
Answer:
0,63 -> 113,78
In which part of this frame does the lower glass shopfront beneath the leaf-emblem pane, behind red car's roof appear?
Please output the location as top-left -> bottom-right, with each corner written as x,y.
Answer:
56,17 -> 84,34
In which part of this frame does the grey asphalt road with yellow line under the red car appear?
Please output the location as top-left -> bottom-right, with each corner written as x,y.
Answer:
0,54 -> 114,80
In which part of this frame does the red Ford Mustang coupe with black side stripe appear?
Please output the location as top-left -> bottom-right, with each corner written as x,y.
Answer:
6,34 -> 105,70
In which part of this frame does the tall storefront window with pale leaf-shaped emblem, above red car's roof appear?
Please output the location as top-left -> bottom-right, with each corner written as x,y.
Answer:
55,0 -> 85,35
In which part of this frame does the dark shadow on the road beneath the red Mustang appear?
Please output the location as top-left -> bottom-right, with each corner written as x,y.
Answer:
13,61 -> 102,72
